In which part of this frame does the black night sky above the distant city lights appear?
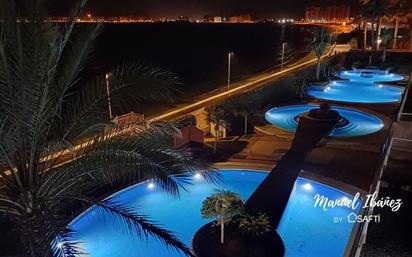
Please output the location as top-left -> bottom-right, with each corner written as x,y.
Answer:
53,0 -> 357,18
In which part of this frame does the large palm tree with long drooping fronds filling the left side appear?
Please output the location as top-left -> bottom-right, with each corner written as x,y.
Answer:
0,0 -> 214,257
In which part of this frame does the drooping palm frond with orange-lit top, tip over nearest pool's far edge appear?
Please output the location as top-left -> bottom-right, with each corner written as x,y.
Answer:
53,123 -> 214,195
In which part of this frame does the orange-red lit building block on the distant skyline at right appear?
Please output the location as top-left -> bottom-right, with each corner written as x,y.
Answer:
305,5 -> 350,22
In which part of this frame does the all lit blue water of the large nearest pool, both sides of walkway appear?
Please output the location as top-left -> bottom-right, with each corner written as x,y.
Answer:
62,170 -> 359,257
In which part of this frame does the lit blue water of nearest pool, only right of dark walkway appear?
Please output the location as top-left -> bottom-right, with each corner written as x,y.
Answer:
278,178 -> 362,257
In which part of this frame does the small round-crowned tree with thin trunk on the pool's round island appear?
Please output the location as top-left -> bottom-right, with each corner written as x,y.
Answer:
201,190 -> 244,244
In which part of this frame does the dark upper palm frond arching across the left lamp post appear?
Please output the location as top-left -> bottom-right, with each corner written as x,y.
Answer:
56,61 -> 180,140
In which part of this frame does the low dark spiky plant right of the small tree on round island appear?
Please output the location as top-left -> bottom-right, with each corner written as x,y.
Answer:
239,213 -> 272,239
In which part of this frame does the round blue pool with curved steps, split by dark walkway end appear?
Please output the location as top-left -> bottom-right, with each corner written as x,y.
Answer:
265,105 -> 383,137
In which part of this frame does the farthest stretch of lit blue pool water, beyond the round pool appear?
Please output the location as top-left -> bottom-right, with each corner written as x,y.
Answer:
309,70 -> 403,103
